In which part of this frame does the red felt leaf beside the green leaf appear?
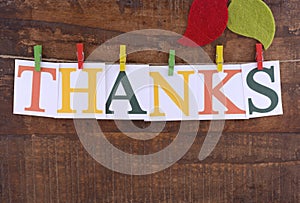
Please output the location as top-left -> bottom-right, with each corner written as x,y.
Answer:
178,0 -> 228,47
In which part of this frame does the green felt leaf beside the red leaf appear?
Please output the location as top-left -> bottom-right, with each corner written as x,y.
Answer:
227,0 -> 276,49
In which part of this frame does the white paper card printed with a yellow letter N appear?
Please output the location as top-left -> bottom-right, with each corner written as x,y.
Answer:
147,66 -> 200,121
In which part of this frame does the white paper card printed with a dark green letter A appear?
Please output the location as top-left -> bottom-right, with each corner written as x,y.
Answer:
106,65 -> 150,120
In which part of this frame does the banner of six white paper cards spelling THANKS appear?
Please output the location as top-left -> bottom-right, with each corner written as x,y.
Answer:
14,60 -> 283,121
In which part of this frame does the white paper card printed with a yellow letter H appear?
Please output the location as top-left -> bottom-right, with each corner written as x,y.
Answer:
57,63 -> 106,119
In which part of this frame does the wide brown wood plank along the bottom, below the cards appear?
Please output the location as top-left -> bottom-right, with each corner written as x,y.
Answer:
0,133 -> 300,202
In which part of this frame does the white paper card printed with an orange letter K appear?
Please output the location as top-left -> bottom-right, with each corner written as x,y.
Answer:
194,65 -> 247,120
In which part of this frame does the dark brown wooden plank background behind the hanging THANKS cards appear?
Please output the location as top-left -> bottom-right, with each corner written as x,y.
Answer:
0,0 -> 300,203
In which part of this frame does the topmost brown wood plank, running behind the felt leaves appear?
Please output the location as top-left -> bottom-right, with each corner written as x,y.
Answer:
0,0 -> 299,34
